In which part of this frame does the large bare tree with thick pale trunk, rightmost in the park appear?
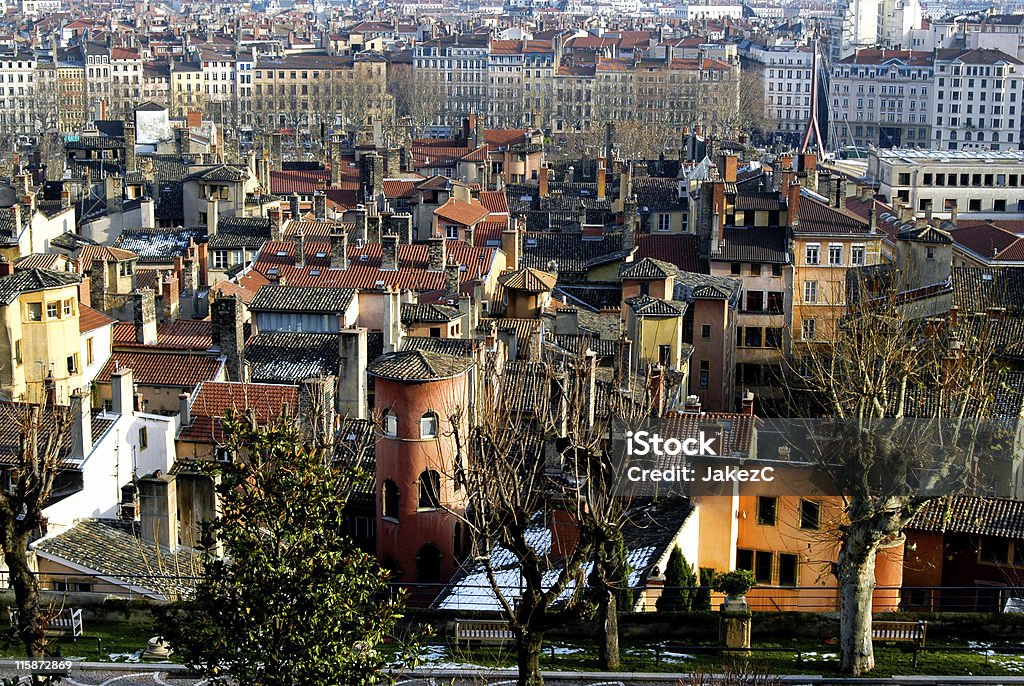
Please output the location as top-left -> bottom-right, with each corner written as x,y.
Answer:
787,276 -> 1005,675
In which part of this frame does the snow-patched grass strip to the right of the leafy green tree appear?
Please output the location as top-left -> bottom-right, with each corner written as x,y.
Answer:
397,640 -> 1024,677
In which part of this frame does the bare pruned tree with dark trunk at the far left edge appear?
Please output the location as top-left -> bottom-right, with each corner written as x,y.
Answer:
0,402 -> 73,657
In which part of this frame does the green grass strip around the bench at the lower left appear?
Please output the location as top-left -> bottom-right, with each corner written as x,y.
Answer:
0,619 -> 164,662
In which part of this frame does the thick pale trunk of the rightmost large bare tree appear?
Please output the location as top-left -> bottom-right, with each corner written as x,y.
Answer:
837,523 -> 878,676
